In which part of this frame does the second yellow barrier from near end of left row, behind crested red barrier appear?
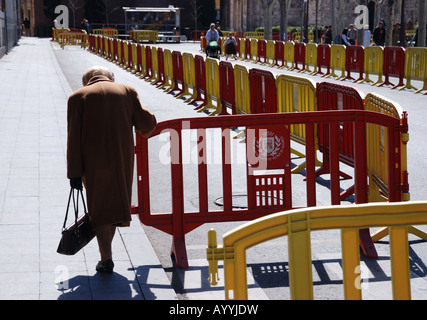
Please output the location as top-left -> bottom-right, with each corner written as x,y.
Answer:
276,74 -> 322,173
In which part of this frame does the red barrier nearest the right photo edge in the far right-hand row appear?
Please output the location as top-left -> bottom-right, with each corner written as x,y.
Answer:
379,47 -> 405,89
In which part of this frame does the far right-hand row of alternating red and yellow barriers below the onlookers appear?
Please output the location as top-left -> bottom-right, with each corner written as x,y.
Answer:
200,37 -> 427,95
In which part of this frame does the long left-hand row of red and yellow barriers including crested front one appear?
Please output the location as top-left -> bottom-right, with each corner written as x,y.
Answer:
83,36 -> 422,267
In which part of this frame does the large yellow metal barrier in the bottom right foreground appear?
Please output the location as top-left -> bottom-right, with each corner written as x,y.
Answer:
206,202 -> 427,300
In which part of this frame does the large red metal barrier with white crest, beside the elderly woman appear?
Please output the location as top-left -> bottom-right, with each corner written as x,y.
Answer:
132,110 -> 401,268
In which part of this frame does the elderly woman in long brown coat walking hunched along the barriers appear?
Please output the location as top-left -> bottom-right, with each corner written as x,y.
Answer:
67,67 -> 156,273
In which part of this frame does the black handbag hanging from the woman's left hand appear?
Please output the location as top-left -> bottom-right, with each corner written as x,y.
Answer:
57,188 -> 95,256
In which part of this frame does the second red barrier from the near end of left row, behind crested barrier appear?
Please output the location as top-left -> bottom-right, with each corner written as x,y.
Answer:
249,69 -> 277,114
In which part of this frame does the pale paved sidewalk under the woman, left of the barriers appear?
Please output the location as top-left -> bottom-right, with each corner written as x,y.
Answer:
0,38 -> 177,300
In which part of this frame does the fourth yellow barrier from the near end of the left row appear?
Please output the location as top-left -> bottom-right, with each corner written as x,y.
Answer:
198,58 -> 222,116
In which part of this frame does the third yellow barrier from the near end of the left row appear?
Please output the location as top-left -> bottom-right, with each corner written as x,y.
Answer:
234,64 -> 251,114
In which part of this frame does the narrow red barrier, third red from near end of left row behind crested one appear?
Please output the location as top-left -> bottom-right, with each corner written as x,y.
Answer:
219,61 -> 236,115
